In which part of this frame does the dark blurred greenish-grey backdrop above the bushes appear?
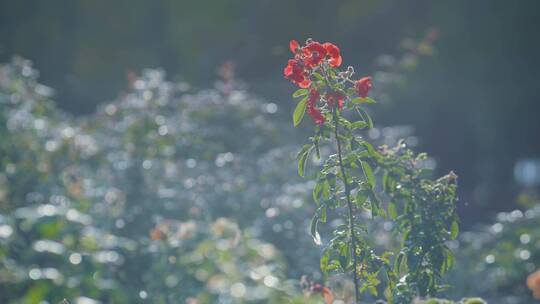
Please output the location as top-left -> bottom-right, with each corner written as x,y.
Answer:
0,0 -> 540,223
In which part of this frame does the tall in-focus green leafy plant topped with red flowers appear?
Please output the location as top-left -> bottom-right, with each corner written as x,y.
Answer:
284,39 -> 458,303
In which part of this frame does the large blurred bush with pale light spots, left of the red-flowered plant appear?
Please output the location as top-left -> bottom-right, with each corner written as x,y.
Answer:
0,59 -> 318,303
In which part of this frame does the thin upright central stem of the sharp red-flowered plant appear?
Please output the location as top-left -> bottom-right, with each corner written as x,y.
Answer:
333,107 -> 360,303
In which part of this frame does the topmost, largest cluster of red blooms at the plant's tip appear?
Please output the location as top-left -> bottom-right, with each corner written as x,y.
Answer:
283,40 -> 342,88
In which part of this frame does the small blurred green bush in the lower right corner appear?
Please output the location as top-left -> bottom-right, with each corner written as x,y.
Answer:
450,205 -> 540,304
